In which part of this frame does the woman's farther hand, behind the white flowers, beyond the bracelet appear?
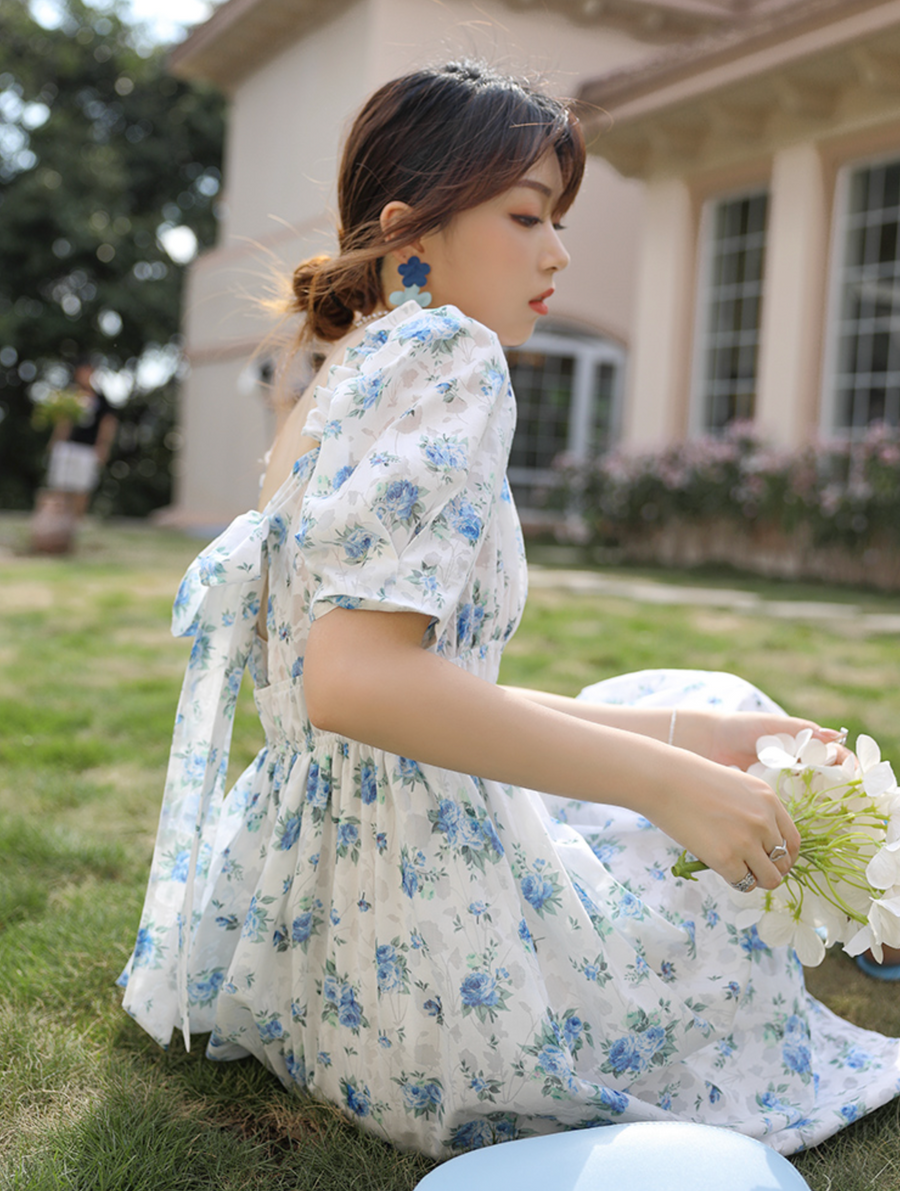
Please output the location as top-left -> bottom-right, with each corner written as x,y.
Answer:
674,710 -> 849,769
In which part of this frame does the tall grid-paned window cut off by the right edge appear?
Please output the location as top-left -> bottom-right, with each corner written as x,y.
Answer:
831,160 -> 900,434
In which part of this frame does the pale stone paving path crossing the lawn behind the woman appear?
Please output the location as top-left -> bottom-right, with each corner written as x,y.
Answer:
529,565 -> 900,635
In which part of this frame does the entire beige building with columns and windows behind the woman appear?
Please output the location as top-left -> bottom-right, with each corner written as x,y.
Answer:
170,0 -> 900,526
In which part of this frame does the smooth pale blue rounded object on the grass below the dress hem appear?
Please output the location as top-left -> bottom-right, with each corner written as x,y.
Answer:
415,1121 -> 810,1191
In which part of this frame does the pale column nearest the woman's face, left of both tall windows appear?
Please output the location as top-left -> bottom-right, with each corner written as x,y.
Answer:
623,179 -> 696,448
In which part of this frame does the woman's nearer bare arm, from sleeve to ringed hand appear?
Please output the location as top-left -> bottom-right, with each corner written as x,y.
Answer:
304,607 -> 800,888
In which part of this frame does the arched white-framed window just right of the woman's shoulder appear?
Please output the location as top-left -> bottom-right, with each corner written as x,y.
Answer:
506,325 -> 625,509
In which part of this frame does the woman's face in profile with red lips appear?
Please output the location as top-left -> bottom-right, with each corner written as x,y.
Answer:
407,150 -> 569,345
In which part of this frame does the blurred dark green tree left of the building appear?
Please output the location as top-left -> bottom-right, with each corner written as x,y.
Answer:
0,0 -> 224,515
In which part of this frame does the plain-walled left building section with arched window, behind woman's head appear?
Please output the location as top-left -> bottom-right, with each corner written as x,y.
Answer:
163,0 -> 730,526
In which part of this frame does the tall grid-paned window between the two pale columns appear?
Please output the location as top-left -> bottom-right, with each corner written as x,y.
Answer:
696,191 -> 769,432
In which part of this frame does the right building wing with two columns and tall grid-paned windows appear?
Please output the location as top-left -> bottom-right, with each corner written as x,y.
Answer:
582,0 -> 900,448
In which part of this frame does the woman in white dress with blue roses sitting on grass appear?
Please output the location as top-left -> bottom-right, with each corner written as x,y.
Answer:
119,64 -> 898,1156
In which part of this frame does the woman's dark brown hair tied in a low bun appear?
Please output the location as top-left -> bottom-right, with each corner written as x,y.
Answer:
289,61 -> 585,341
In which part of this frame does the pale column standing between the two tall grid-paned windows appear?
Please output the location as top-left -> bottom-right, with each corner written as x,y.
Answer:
756,143 -> 829,447
